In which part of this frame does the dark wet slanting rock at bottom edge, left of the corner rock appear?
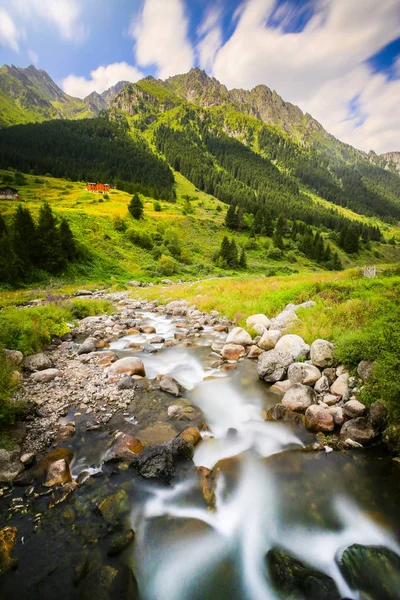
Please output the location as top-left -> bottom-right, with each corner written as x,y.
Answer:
266,548 -> 341,600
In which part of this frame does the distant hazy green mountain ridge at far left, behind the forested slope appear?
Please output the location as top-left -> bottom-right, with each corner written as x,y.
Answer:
0,65 -> 125,127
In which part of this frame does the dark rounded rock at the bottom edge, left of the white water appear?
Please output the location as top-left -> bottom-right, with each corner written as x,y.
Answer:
79,564 -> 139,600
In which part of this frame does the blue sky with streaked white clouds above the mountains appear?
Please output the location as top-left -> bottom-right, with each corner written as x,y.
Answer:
0,0 -> 400,154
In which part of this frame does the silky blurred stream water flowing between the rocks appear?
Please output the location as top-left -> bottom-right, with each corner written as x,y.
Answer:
0,313 -> 400,600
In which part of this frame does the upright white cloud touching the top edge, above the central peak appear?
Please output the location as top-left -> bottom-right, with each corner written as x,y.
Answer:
130,0 -> 194,78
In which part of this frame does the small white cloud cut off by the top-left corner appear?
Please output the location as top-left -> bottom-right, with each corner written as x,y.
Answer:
13,0 -> 88,42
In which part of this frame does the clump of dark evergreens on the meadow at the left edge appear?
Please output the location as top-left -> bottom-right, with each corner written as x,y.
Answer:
0,202 -> 79,286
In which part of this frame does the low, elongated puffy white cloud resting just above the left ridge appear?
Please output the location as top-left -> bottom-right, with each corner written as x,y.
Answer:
61,62 -> 143,98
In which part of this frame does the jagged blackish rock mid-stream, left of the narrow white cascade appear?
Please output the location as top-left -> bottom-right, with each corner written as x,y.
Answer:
132,437 -> 194,483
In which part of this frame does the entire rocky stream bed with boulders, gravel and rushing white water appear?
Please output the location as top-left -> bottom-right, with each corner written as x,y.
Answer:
0,292 -> 400,600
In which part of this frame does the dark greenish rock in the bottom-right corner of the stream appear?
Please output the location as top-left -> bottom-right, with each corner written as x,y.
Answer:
336,544 -> 400,600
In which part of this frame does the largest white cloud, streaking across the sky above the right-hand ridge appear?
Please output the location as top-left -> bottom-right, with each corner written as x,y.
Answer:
212,0 -> 400,152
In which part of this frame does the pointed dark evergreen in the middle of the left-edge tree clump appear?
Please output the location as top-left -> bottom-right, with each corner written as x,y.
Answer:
37,202 -> 64,273
